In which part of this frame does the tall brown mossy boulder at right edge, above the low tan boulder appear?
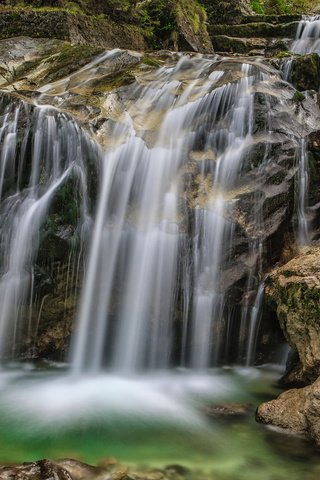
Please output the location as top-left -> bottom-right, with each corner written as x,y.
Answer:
266,246 -> 320,383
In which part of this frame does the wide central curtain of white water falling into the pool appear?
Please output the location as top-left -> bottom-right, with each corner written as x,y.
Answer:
72,56 -> 276,373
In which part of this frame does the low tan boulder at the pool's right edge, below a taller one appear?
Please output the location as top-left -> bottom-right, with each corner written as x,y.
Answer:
256,378 -> 320,445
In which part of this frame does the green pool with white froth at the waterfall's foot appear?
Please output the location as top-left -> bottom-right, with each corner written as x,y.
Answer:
0,370 -> 320,480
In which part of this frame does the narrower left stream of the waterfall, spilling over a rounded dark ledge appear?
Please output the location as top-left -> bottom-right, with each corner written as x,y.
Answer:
0,97 -> 100,358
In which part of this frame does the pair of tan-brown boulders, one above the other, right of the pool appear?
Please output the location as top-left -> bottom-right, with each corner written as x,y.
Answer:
256,246 -> 320,445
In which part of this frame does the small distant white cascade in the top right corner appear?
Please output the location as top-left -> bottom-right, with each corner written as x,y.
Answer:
290,15 -> 320,55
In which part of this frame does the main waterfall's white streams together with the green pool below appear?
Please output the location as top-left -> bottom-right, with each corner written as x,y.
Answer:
0,45 -> 318,480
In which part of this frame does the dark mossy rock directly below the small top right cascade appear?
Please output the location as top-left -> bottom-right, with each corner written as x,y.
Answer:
289,53 -> 320,91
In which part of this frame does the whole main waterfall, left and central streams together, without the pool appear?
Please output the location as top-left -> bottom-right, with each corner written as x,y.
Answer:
0,52 -> 307,374
